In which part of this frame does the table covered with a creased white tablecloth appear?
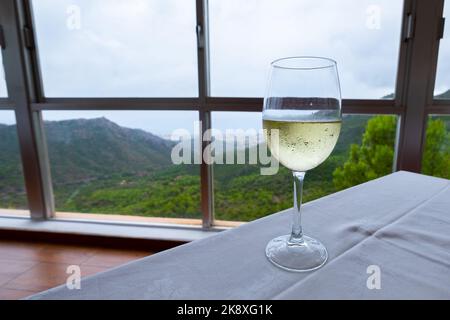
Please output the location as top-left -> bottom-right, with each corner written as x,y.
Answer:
30,171 -> 450,299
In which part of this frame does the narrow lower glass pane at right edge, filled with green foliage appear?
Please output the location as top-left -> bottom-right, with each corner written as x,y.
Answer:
422,116 -> 450,179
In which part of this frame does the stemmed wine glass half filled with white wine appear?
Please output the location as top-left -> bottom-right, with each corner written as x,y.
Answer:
263,57 -> 342,272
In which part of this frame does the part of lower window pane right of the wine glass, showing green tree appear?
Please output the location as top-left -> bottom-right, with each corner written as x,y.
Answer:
330,115 -> 398,190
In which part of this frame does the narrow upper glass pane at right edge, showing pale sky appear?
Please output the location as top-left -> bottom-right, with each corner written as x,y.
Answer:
434,0 -> 450,99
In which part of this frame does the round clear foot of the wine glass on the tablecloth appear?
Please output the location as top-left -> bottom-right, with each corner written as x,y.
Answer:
266,235 -> 328,272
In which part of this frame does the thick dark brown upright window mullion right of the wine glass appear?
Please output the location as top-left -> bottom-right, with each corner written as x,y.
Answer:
396,0 -> 444,172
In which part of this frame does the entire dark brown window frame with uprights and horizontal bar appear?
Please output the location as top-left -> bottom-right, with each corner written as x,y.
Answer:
0,0 -> 450,229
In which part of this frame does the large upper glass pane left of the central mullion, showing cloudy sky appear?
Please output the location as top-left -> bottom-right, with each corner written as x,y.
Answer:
33,0 -> 198,97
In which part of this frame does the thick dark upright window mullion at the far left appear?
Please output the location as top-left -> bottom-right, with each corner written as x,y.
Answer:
0,0 -> 54,219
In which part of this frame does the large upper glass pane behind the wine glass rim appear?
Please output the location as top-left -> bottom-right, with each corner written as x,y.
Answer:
209,0 -> 403,99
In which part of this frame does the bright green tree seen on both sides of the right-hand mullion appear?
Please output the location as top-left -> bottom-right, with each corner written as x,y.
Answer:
333,116 -> 450,189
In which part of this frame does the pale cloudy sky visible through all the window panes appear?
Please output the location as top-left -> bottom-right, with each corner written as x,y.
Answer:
0,0 -> 450,135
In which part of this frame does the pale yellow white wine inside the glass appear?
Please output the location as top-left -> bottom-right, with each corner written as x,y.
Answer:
263,120 -> 342,172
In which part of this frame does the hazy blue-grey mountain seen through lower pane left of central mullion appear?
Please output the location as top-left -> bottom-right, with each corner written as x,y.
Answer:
45,118 -> 173,184
